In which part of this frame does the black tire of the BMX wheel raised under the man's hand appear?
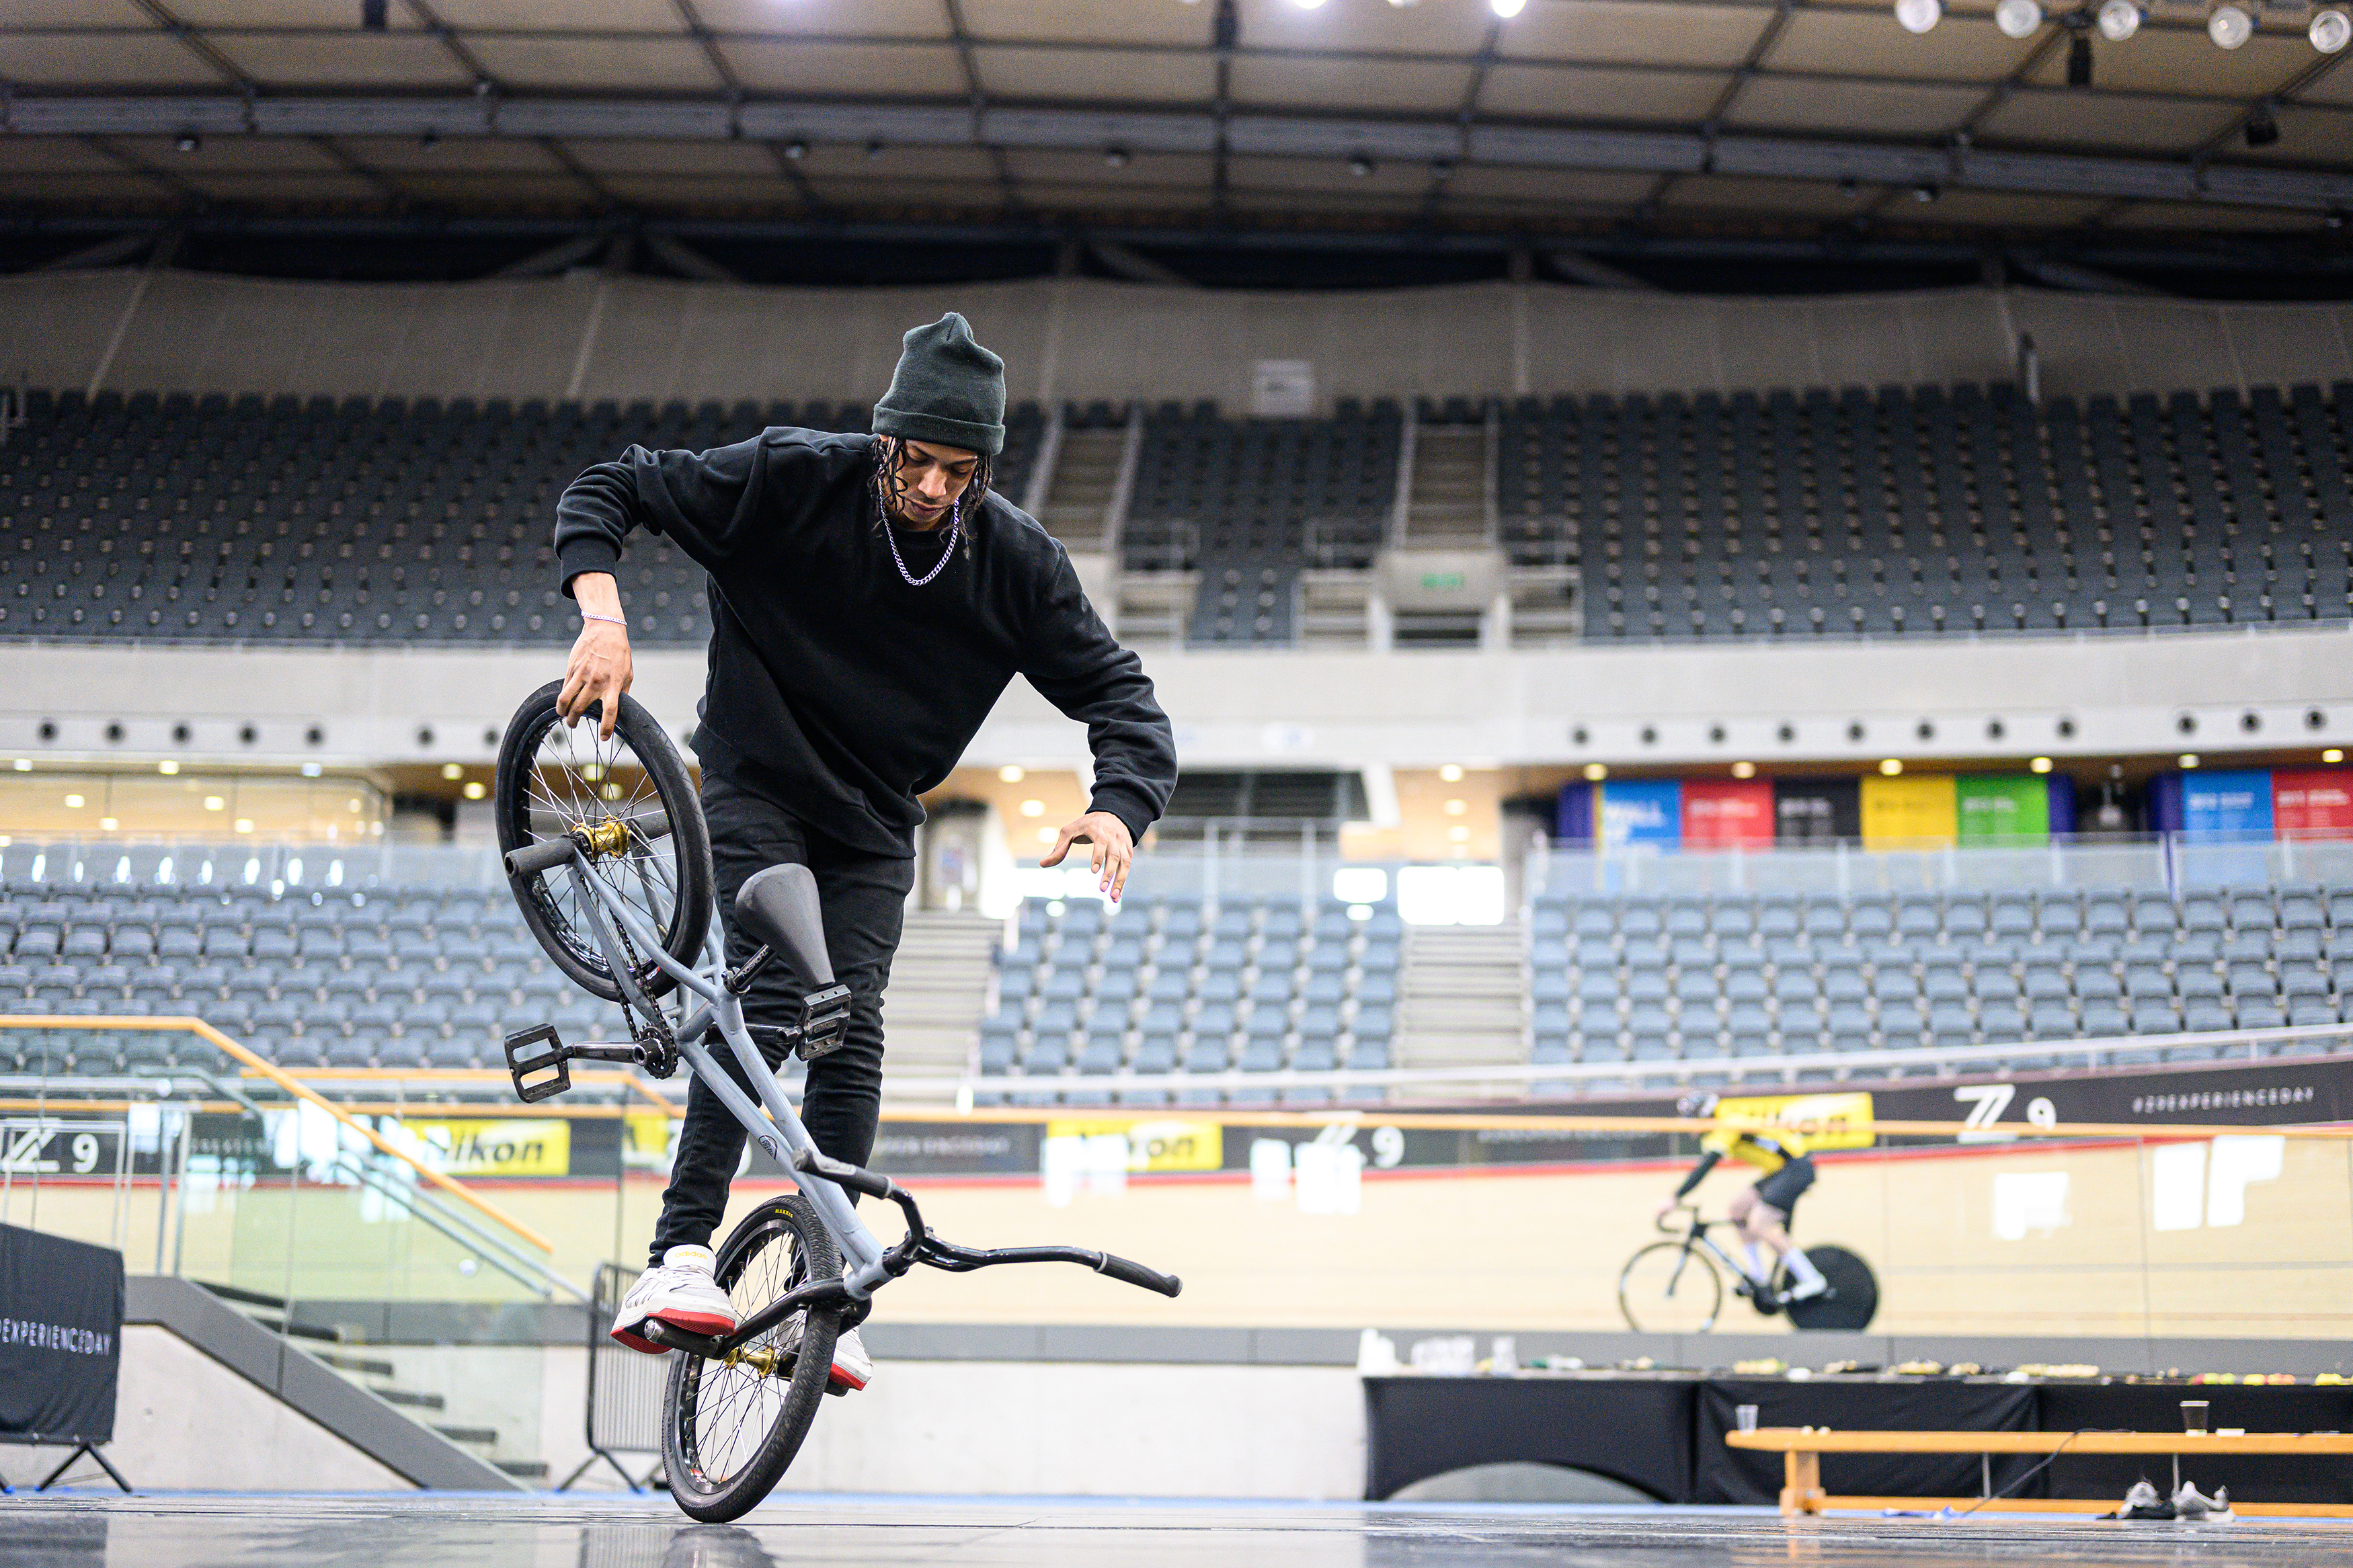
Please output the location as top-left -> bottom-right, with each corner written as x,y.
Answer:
492,682 -> 715,1001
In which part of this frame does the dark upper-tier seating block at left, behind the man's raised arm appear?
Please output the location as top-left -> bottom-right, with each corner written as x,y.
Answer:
0,393 -> 1045,644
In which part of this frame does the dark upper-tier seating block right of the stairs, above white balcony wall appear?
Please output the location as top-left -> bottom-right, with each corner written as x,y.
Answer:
1497,383 -> 2353,637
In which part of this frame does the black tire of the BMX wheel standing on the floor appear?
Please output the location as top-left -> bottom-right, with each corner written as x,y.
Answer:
662,1194 -> 842,1524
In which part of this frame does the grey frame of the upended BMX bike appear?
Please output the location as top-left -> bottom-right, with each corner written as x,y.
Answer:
567,849 -> 892,1300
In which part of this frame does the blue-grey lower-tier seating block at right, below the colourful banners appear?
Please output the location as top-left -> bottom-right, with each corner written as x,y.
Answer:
1529,886 -> 2353,1069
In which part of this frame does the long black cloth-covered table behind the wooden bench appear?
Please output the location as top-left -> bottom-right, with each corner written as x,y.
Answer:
1365,1373 -> 2353,1505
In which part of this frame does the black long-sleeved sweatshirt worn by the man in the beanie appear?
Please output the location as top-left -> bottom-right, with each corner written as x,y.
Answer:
555,428 -> 1176,856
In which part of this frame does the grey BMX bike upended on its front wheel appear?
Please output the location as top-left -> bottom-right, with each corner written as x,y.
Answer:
494,684 -> 1184,1524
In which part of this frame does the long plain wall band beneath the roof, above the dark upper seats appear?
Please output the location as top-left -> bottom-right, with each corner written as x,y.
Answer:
0,270 -> 2353,407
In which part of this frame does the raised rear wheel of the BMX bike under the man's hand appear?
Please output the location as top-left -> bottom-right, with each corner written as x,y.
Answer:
494,682 -> 713,1001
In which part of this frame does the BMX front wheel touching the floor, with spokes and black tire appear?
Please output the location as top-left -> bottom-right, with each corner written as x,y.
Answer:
662,1196 -> 842,1524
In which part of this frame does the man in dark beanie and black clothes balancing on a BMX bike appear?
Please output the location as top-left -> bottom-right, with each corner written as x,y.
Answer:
555,313 -> 1176,1387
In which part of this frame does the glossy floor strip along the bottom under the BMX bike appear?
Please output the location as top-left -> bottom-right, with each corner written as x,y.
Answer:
0,1493 -> 2353,1568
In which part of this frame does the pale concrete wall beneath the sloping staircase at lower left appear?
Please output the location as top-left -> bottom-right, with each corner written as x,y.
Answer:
0,1323 -> 414,1493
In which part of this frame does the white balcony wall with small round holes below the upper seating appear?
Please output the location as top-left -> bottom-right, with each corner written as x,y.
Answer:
0,628 -> 2353,769
